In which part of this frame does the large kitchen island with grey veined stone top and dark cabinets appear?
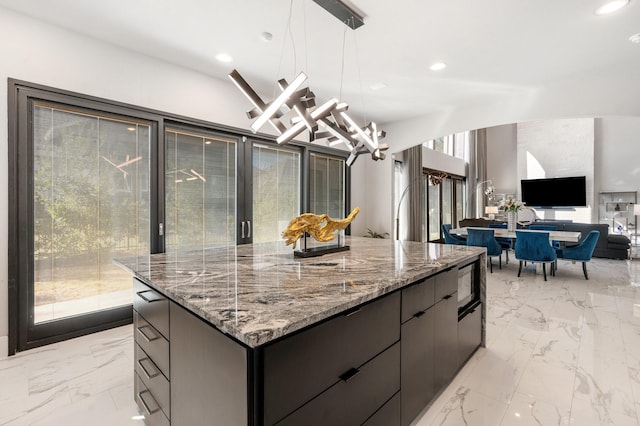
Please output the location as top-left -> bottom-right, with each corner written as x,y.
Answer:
118,237 -> 486,425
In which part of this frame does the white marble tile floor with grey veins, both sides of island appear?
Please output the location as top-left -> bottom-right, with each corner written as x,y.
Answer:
0,255 -> 640,426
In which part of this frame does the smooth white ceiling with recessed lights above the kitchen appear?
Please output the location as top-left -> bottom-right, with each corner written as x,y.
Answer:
0,0 -> 640,122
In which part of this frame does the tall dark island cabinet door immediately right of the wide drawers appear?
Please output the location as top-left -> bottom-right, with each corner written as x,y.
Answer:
400,308 -> 437,425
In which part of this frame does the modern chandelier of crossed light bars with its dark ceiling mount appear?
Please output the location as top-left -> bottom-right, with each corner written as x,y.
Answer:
229,0 -> 389,166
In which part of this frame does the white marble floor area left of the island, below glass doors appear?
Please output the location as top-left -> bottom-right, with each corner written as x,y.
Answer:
0,325 -> 139,426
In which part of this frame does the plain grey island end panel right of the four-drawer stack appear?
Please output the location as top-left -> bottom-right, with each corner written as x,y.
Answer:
170,303 -> 249,426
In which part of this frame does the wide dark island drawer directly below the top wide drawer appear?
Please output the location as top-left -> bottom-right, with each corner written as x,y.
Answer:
278,343 -> 400,426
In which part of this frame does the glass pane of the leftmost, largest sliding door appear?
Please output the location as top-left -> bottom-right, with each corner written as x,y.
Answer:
33,102 -> 150,324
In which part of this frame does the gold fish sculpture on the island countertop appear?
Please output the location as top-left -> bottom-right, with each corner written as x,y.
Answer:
282,207 -> 360,248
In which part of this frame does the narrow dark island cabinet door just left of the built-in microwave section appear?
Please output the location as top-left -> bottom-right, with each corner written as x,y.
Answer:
432,292 -> 458,389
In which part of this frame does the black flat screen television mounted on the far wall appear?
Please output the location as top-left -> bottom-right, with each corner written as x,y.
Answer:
520,176 -> 587,208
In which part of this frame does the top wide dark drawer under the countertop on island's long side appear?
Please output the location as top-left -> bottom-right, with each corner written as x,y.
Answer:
264,292 -> 400,424
